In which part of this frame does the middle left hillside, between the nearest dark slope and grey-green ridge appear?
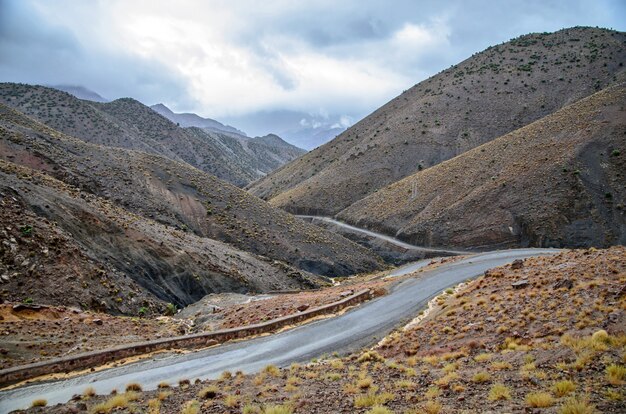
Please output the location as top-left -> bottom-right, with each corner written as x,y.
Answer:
0,105 -> 382,276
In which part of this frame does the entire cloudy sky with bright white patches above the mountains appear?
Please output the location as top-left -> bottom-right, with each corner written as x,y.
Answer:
0,0 -> 626,138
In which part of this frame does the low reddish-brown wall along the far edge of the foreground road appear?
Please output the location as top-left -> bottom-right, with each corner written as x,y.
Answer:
0,289 -> 372,387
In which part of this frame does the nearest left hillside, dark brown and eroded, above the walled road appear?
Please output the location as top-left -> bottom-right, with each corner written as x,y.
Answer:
0,160 -> 319,314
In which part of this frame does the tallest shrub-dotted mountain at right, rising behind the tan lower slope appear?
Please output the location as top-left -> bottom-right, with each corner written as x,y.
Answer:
250,28 -> 626,215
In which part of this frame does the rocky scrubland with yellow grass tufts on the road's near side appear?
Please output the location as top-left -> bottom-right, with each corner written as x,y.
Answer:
23,247 -> 626,414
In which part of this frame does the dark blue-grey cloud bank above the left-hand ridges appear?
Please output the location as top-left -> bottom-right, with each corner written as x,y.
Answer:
0,0 -> 194,107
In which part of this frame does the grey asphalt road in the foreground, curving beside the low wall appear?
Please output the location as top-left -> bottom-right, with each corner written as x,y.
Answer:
0,249 -> 558,413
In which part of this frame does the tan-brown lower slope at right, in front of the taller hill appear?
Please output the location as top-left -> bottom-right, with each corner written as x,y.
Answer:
339,83 -> 626,248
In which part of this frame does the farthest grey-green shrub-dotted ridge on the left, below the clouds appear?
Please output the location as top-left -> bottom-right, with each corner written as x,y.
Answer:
0,83 -> 304,186
